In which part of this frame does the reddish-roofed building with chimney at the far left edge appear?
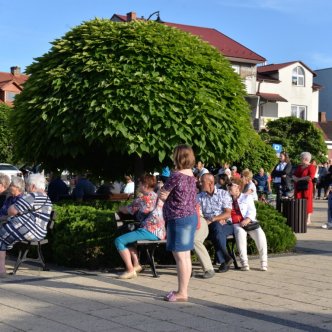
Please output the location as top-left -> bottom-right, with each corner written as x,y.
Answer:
0,67 -> 29,106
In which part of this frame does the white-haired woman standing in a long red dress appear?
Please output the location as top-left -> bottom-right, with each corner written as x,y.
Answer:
293,152 -> 316,224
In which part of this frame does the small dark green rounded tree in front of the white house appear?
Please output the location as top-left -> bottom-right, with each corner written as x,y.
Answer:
260,117 -> 327,163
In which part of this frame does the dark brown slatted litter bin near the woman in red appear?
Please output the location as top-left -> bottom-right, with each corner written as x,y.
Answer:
282,199 -> 307,233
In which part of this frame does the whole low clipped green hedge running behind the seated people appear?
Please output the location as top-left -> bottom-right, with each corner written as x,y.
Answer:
46,201 -> 296,269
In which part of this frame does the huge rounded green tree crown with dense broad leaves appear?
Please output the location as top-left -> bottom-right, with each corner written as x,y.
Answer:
12,19 -> 262,174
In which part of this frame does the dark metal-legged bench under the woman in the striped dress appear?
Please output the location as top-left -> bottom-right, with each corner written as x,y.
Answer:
11,211 -> 55,275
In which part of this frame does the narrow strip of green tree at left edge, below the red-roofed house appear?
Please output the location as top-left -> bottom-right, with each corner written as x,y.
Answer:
0,104 -> 13,163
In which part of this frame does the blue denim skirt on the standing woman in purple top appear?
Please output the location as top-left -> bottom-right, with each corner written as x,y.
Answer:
166,214 -> 197,251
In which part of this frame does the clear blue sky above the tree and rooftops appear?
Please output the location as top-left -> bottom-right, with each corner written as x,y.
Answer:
0,0 -> 332,72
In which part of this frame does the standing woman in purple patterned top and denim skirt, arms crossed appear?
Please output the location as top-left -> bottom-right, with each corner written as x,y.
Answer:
160,145 -> 197,302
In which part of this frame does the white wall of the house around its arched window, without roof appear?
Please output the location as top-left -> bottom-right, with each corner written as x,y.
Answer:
257,63 -> 319,122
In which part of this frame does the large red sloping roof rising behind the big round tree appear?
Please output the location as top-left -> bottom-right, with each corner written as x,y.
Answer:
112,14 -> 266,63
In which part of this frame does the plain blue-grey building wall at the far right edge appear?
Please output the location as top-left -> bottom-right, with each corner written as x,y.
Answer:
314,68 -> 332,120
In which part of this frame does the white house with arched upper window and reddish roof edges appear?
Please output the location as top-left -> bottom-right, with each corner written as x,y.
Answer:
255,61 -> 320,130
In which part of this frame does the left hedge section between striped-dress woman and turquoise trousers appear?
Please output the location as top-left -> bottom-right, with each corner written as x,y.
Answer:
49,202 -> 121,268
